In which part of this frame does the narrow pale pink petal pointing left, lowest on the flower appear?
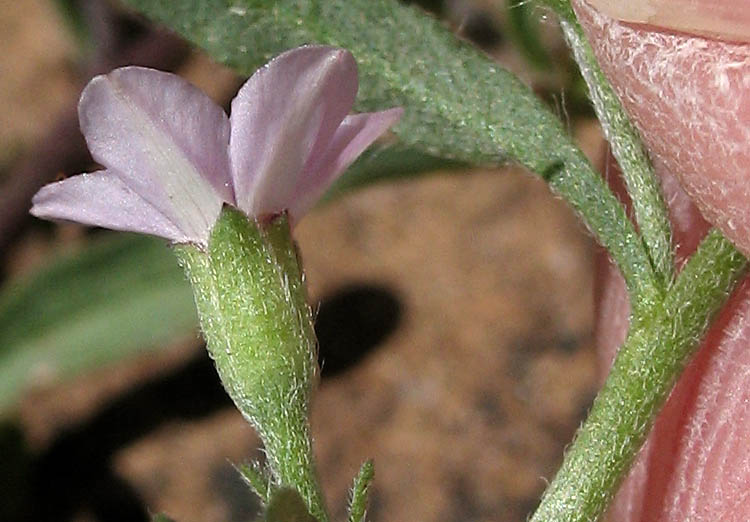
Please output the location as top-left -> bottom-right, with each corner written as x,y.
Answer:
31,171 -> 191,243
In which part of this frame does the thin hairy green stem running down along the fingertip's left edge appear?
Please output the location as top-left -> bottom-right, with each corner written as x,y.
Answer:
560,18 -> 674,288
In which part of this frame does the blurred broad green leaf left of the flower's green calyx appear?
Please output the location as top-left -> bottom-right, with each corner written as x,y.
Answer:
0,234 -> 198,411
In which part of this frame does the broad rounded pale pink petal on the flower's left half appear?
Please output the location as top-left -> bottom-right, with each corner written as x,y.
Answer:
78,67 -> 234,242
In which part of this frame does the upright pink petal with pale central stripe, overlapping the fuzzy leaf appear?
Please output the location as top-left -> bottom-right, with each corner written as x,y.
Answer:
229,46 -> 357,215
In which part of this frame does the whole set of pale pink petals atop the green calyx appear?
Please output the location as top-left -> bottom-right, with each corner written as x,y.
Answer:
31,46 -> 403,245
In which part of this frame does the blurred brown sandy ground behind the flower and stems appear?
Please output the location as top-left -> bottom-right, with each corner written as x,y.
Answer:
0,0 -> 600,522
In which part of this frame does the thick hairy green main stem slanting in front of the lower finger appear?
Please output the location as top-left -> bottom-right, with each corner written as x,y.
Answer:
531,230 -> 747,522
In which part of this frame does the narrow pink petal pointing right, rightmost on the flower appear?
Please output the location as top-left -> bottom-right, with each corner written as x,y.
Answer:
286,107 -> 404,222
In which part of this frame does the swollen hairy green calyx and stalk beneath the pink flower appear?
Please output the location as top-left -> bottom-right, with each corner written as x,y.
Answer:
175,207 -> 328,522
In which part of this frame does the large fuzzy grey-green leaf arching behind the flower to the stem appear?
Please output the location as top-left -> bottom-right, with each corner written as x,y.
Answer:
125,0 -> 659,330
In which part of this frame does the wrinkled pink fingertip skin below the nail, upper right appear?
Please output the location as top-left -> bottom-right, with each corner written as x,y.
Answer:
574,0 -> 750,254
